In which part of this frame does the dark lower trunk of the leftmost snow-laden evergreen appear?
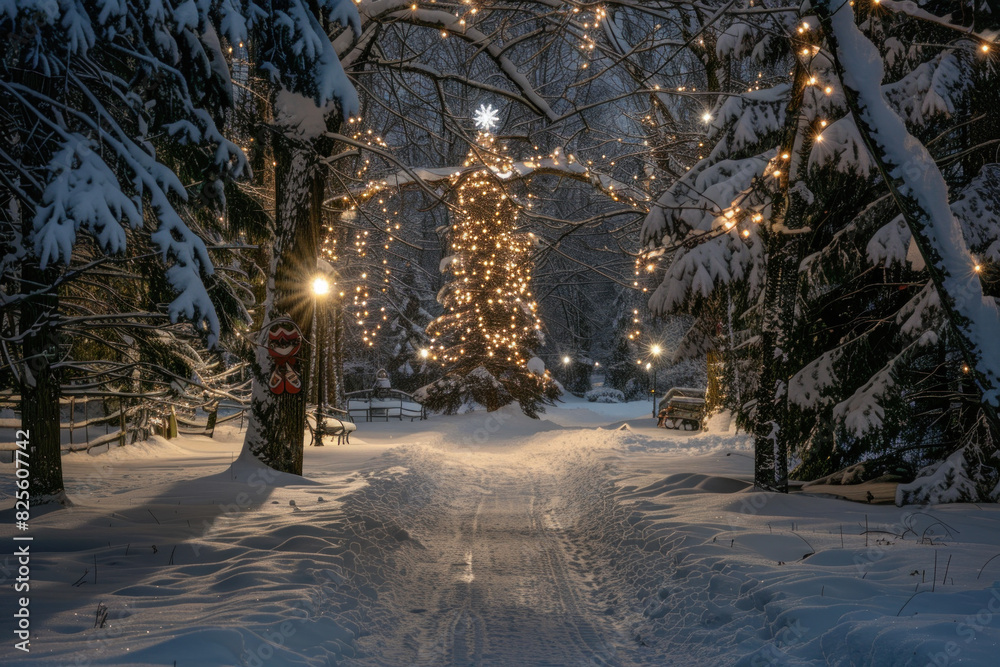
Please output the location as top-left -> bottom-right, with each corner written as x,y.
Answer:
20,258 -> 63,504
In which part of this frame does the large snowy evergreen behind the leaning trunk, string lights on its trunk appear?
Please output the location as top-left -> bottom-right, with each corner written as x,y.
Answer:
644,2 -> 997,498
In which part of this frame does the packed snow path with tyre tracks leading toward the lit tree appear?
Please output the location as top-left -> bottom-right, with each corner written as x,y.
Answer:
348,454 -> 619,665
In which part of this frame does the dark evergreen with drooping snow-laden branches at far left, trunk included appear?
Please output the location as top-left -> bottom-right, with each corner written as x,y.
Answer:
0,1 -> 246,501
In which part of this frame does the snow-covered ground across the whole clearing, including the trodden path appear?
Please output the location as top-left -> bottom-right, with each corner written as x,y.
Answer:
0,401 -> 1000,667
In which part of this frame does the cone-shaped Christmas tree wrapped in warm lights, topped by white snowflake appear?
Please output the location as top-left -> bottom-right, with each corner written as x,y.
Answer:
417,107 -> 560,417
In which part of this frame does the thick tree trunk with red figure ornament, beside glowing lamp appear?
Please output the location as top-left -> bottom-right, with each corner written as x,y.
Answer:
244,141 -> 323,475
